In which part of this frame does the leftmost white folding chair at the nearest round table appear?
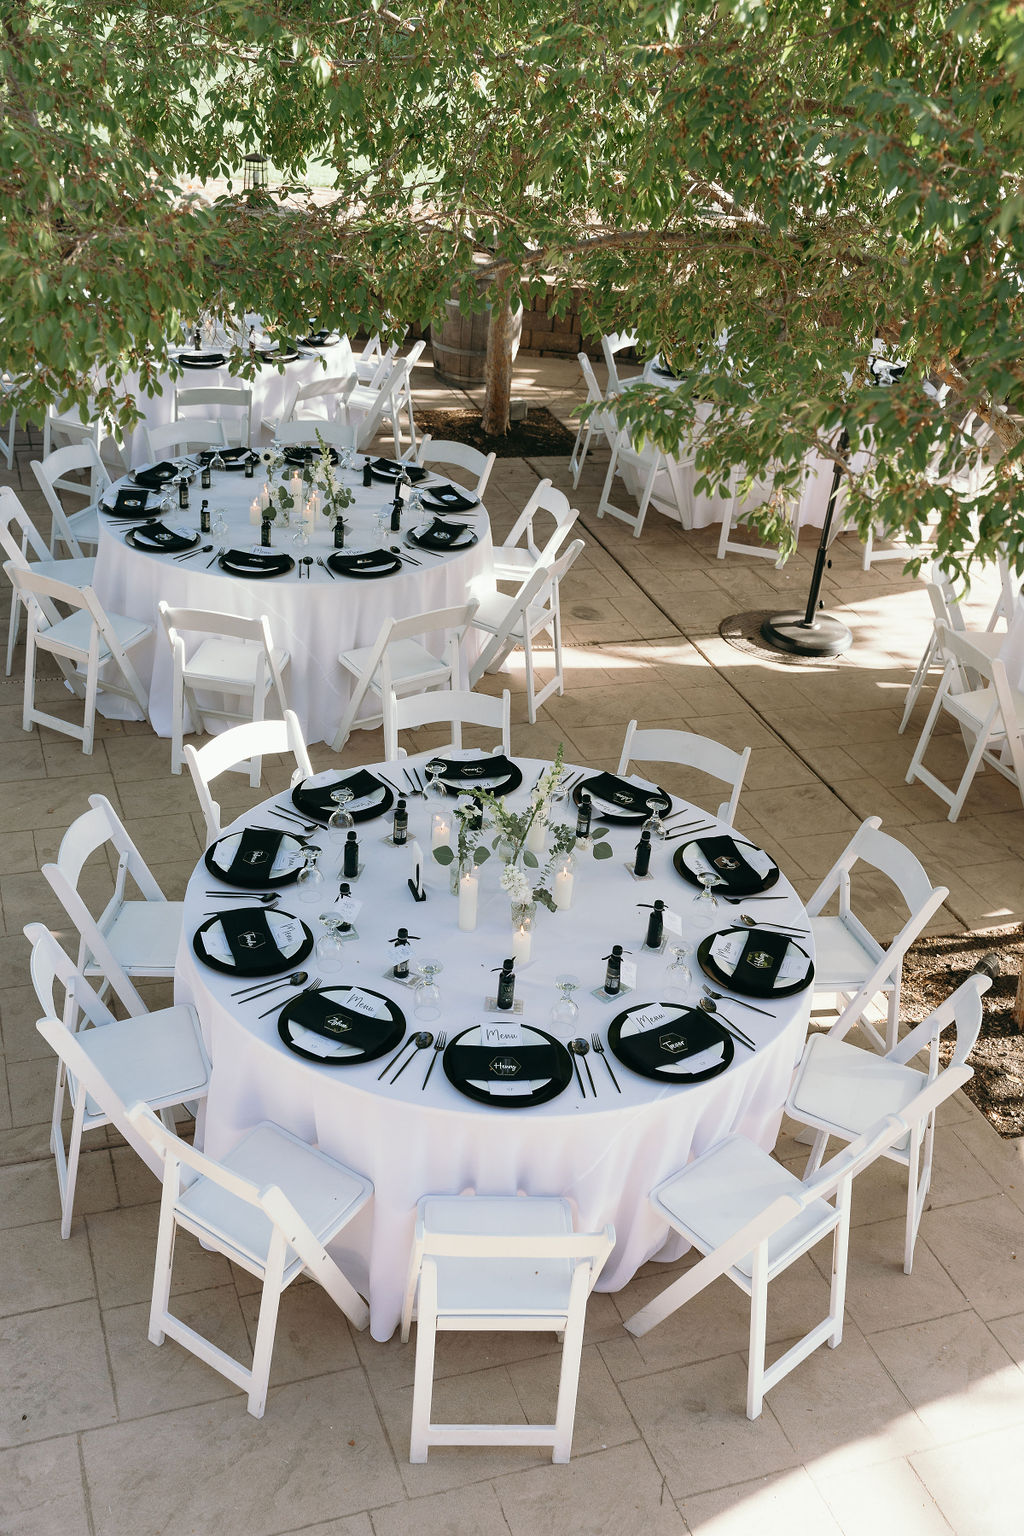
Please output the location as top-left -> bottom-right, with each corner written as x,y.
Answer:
25,923 -> 210,1238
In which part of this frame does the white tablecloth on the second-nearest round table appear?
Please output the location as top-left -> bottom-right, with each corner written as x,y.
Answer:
94,461 -> 493,742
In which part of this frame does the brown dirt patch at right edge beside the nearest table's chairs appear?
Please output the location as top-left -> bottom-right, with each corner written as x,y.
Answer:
903,923 -> 1024,1137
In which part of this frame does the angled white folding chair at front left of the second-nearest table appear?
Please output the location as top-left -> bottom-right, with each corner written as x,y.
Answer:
3,561 -> 152,754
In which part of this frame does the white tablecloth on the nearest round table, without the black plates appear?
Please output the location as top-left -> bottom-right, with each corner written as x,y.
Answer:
175,753 -> 812,1339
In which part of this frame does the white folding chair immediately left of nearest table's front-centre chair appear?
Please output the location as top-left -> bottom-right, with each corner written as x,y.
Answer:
127,1103 -> 373,1419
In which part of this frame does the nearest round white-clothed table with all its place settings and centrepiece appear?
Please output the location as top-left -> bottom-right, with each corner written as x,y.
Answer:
175,750 -> 814,1338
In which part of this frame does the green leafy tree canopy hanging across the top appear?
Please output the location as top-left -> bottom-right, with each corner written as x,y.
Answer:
0,0 -> 1024,568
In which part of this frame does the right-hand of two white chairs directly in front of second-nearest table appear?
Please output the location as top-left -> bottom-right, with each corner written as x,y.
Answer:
333,602 -> 476,753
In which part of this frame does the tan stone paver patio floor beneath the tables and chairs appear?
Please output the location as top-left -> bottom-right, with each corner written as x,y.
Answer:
0,358 -> 1024,1536
